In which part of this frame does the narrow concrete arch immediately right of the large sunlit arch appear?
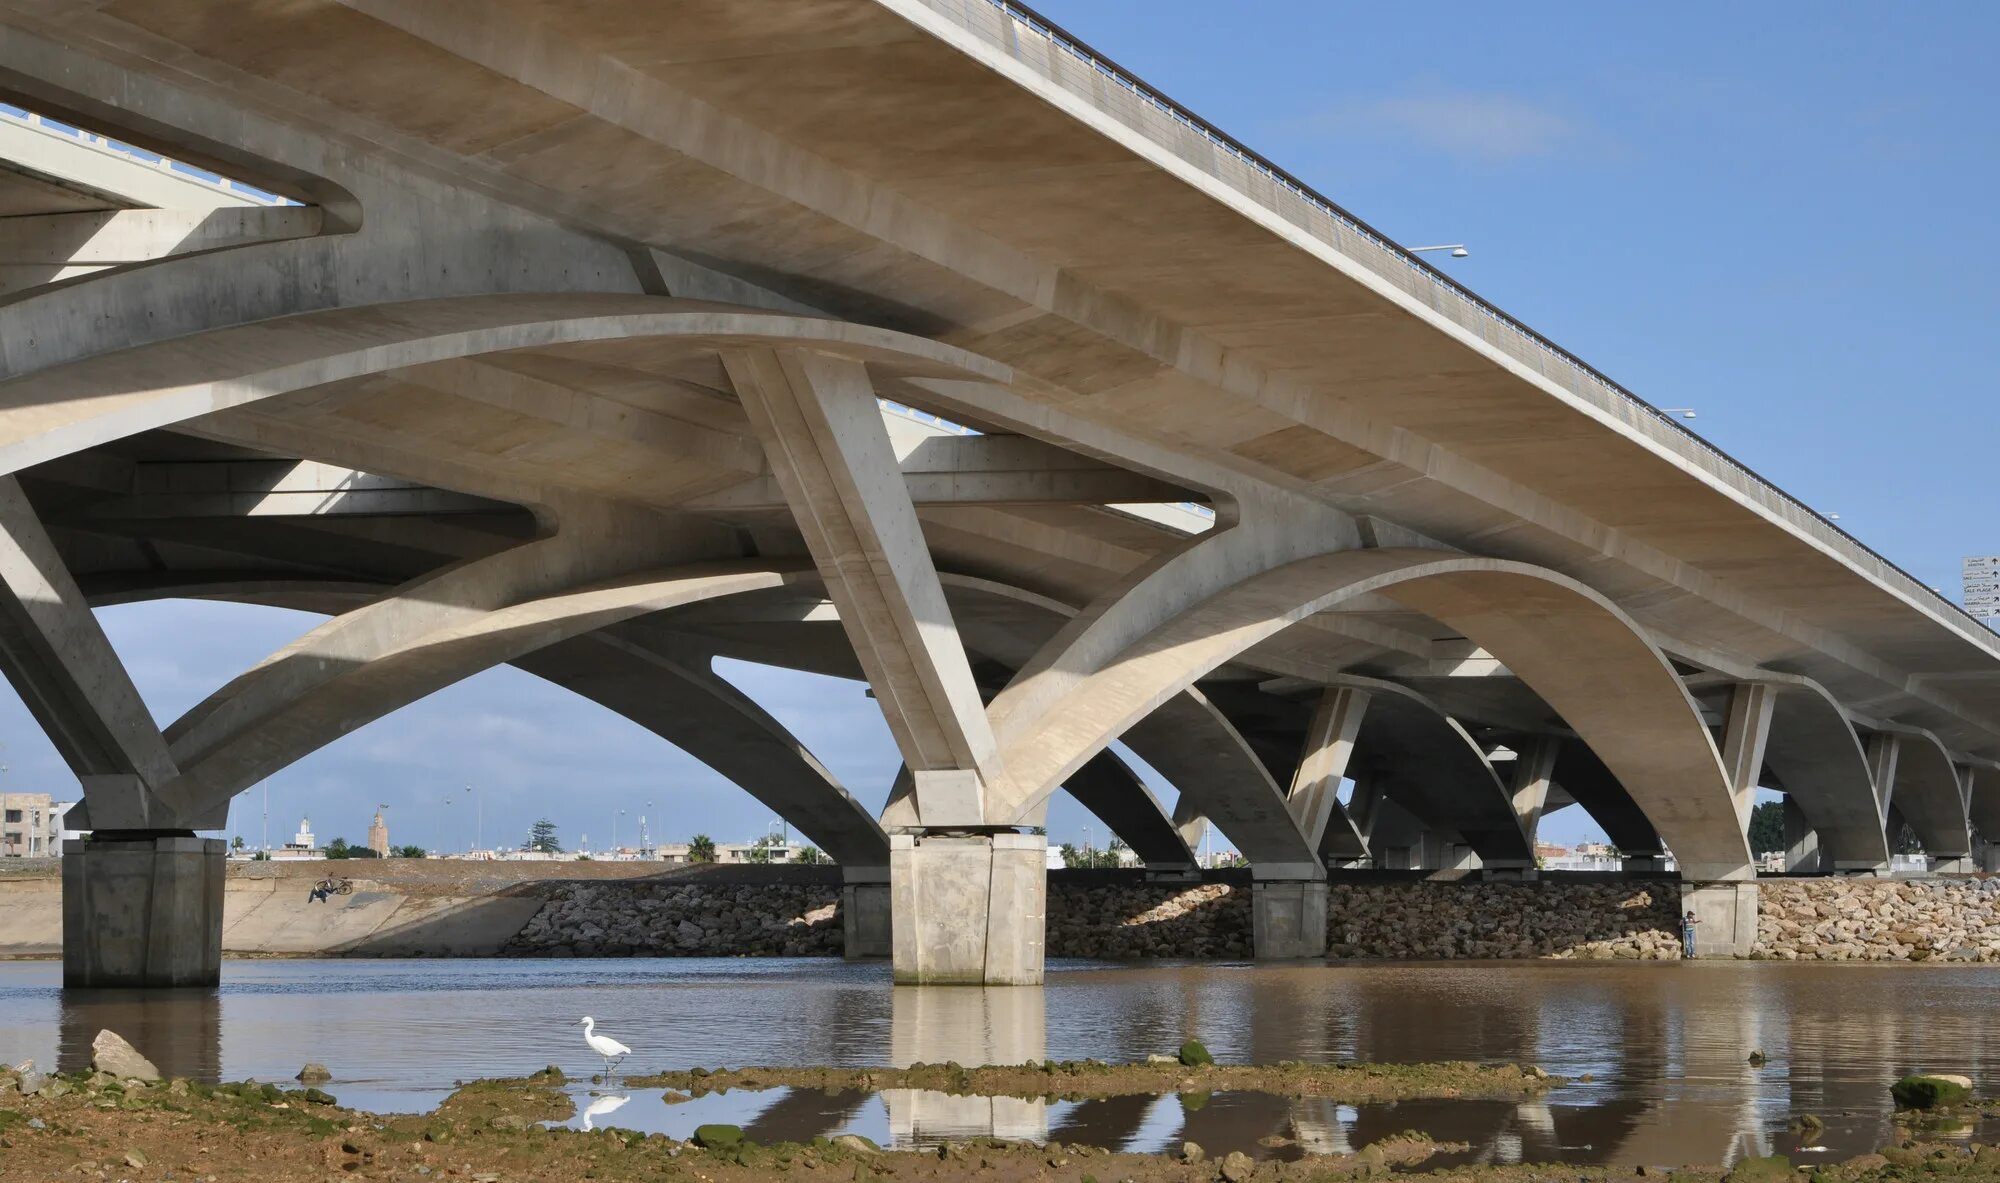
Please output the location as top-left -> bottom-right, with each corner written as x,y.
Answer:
1764,677 -> 1890,867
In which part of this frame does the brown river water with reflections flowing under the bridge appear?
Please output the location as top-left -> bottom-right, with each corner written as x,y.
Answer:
0,959 -> 2000,1165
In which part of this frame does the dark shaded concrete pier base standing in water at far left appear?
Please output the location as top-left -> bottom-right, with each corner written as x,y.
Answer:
62,833 -> 226,987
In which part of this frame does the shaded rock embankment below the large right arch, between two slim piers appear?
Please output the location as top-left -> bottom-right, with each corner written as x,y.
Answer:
1326,881 -> 1680,961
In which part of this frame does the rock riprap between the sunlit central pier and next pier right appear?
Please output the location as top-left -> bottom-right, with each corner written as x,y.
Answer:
1044,883 -> 1250,959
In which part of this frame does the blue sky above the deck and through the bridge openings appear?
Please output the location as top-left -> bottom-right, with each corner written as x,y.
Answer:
0,0 -> 2000,847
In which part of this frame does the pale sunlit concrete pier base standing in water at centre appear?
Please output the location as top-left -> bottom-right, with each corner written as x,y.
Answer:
888,833 -> 1048,985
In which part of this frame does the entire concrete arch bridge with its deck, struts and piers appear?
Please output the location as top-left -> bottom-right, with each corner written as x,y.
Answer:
0,0 -> 2000,985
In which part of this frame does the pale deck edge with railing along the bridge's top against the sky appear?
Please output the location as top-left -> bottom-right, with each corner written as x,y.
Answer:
924,0 -> 2000,633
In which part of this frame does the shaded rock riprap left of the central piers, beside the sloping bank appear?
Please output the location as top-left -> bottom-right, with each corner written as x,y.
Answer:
504,883 -> 842,957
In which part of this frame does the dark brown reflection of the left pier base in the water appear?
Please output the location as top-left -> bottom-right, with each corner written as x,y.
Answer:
56,989 -> 222,1081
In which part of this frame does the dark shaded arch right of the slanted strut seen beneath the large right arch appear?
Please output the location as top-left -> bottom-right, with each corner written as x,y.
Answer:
1338,677 -> 1534,865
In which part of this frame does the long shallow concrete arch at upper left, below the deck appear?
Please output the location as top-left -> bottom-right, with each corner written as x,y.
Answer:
0,294 -> 1014,474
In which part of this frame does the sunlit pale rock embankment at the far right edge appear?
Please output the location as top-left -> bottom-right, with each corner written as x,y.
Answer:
1754,879 -> 2000,961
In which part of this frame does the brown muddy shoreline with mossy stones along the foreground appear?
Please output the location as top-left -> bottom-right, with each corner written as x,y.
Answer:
0,1065 -> 2000,1183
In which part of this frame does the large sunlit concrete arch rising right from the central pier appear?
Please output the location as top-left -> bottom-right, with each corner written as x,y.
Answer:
990,548 -> 1750,877
